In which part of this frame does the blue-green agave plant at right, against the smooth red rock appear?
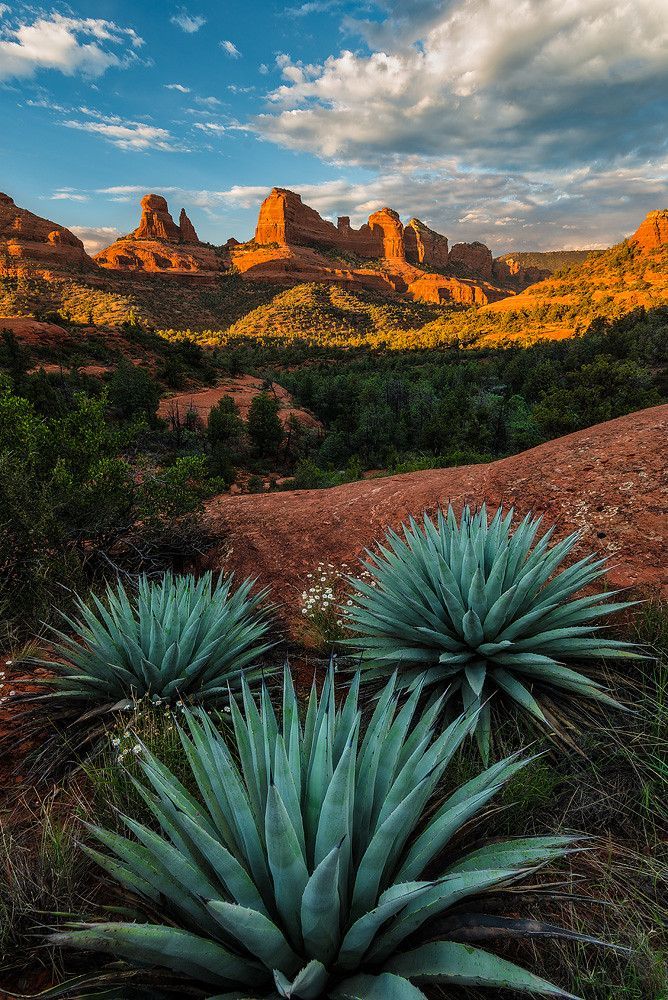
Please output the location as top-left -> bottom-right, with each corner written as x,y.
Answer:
345,505 -> 637,761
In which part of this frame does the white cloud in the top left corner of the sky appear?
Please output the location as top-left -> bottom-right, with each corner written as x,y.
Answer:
0,13 -> 143,80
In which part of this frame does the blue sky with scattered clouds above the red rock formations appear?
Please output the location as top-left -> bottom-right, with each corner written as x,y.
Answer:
0,0 -> 668,255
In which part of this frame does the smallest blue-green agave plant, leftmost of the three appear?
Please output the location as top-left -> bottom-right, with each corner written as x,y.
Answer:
34,573 -> 271,708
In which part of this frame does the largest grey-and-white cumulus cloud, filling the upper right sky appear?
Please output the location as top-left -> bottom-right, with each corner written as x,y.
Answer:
256,0 -> 668,169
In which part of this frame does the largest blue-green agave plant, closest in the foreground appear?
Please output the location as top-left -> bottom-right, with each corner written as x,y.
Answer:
52,669 -> 592,1000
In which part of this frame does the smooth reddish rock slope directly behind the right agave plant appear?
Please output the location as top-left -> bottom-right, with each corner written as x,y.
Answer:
206,405 -> 668,624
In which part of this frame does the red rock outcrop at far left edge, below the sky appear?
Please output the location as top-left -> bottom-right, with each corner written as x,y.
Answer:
0,194 -> 94,275
